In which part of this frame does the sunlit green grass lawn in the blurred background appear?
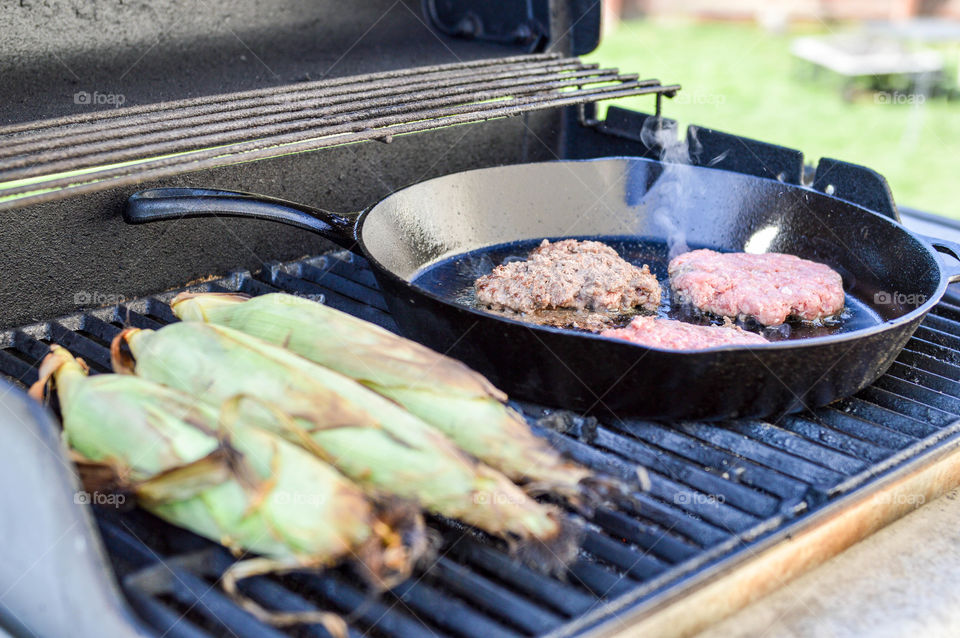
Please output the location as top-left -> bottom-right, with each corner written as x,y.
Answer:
588,21 -> 960,219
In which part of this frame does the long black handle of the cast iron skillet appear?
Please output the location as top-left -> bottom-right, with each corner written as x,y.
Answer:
123,188 -> 360,251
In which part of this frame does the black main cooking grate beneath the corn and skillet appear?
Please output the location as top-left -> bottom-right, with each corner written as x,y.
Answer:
0,253 -> 960,637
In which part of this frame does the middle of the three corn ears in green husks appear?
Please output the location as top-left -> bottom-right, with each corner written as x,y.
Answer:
112,322 -> 575,560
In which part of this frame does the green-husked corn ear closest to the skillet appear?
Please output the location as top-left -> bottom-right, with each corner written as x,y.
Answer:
171,293 -> 593,500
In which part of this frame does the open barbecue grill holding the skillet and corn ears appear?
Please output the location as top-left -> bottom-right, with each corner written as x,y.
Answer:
0,0 -> 960,637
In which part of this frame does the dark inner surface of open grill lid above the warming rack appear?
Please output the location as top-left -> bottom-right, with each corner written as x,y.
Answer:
0,0 -> 600,125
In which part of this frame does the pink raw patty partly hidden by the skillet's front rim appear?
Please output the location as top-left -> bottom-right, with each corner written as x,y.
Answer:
600,317 -> 767,350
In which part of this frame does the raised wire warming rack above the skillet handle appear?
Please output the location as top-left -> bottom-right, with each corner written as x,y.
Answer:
0,54 -> 680,210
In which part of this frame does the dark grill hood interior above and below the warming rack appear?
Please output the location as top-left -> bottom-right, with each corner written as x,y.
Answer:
0,0 -> 616,326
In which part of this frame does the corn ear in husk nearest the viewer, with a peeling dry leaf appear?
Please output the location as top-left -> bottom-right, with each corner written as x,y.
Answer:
31,346 -> 422,631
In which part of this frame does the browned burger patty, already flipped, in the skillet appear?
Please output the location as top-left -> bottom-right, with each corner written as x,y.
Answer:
474,239 -> 660,313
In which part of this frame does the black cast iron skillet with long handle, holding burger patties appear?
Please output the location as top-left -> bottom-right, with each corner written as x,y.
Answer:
125,158 -> 960,419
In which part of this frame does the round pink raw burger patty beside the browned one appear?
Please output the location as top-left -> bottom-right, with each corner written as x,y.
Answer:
668,249 -> 844,326
